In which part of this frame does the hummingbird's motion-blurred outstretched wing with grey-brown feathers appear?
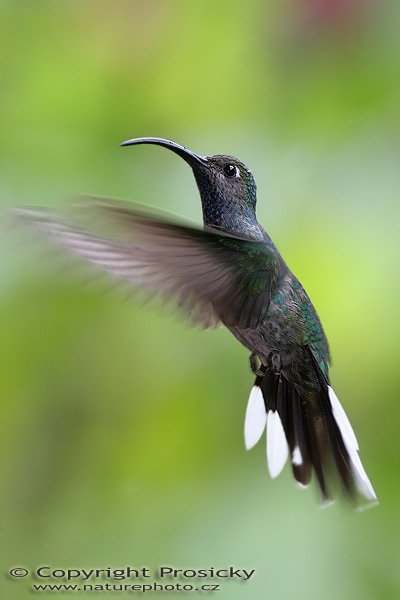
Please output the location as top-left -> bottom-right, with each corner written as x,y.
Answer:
16,200 -> 277,328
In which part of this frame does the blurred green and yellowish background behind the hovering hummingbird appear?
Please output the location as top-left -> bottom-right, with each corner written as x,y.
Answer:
0,0 -> 400,600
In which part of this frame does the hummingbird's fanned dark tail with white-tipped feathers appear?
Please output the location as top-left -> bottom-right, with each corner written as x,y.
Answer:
245,352 -> 377,504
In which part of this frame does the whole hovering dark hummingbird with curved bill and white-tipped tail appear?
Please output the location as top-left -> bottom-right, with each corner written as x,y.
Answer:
18,137 -> 377,507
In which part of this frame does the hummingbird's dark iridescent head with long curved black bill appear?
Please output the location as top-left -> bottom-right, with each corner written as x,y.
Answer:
121,137 -> 260,237
